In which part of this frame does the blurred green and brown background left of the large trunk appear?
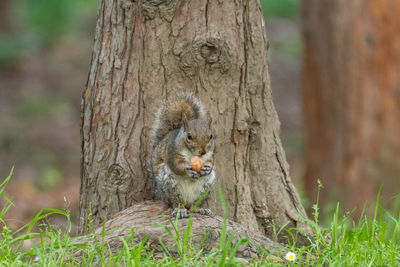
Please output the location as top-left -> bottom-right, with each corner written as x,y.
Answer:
0,0 -> 97,231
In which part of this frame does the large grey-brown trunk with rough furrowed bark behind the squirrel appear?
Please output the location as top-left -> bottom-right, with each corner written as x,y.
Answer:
79,0 -> 310,245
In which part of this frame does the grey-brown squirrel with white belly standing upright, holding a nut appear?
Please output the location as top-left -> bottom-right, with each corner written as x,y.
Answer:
150,94 -> 215,218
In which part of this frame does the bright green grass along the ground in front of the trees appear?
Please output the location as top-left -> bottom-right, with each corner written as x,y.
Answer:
0,172 -> 400,266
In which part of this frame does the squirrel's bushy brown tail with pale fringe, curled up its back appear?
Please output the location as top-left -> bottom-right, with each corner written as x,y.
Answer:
152,94 -> 203,145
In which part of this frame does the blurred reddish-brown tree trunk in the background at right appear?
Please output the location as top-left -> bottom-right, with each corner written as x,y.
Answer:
303,0 -> 400,215
